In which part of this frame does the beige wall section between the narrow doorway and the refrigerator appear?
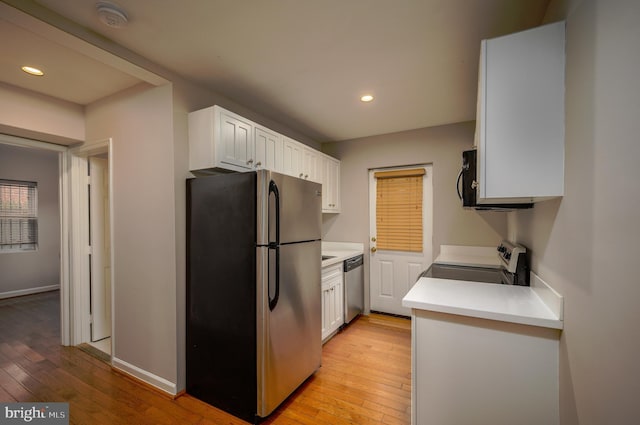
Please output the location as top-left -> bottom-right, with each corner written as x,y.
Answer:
86,84 -> 177,384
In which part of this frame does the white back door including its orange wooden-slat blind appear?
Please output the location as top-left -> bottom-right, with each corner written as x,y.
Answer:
369,164 -> 433,316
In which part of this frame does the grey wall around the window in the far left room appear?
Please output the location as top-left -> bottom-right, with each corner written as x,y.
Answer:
0,144 -> 60,298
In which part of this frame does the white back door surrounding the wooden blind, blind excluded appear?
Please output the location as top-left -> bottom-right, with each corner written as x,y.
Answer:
369,165 -> 433,316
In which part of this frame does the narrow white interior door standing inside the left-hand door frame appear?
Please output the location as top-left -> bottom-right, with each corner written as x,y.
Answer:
89,157 -> 111,342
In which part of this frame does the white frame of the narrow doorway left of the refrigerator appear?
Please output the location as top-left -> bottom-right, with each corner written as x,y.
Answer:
69,139 -> 115,353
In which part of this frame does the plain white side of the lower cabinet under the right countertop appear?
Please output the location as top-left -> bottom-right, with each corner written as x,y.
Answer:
411,309 -> 560,425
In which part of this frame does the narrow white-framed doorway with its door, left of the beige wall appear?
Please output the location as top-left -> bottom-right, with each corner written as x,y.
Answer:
70,139 -> 113,360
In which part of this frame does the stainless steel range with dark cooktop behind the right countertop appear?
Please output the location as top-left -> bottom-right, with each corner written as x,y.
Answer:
420,241 -> 529,286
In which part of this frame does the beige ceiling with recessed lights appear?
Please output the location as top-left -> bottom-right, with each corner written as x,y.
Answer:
0,0 -> 549,142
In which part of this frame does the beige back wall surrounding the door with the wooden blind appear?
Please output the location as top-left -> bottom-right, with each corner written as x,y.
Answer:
322,122 -> 507,310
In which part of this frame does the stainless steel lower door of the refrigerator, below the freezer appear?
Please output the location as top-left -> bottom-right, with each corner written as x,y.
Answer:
257,241 -> 322,417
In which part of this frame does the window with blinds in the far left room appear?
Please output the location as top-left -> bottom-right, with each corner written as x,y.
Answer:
0,180 -> 38,252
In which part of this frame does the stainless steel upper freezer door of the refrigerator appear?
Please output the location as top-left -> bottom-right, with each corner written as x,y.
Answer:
257,170 -> 322,245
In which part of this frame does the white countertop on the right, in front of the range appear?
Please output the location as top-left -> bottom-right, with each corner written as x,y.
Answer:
402,273 -> 563,329
